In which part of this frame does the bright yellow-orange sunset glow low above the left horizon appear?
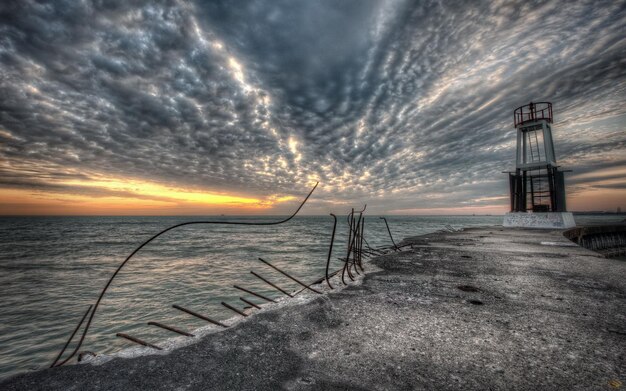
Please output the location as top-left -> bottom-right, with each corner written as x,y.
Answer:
0,177 -> 294,215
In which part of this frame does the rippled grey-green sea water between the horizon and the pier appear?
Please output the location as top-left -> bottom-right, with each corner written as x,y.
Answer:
0,216 -> 616,378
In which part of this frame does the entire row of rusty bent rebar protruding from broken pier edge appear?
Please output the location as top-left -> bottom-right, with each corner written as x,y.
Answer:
50,183 -> 400,368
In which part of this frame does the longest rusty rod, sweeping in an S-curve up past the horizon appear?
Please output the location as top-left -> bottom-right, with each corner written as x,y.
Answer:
53,182 -> 319,366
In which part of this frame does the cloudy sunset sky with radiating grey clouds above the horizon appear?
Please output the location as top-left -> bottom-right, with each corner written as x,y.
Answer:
0,0 -> 626,215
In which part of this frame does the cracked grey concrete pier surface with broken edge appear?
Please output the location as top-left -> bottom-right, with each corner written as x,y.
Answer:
0,227 -> 626,390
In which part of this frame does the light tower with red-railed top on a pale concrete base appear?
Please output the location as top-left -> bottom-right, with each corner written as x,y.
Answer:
504,102 -> 576,228
